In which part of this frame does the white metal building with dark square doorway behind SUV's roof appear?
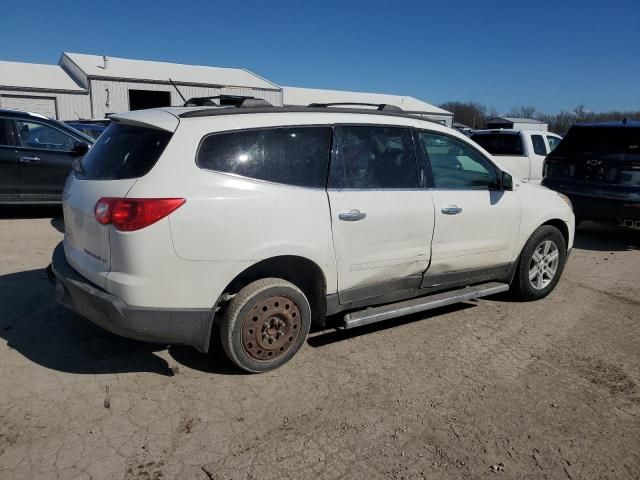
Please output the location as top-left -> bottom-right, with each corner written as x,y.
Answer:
60,52 -> 282,118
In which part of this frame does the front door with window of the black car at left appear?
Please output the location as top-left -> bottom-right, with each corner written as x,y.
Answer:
15,119 -> 79,202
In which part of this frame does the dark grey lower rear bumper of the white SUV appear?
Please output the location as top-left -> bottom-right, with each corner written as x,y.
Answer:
47,243 -> 213,352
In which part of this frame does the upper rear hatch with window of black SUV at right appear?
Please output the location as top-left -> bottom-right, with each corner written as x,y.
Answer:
544,124 -> 640,198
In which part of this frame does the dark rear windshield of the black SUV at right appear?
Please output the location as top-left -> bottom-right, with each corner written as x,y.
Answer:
553,127 -> 640,157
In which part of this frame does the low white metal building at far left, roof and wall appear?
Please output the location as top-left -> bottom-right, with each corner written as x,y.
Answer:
0,61 -> 91,120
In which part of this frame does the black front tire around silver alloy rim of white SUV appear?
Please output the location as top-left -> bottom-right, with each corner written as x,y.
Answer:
511,225 -> 567,301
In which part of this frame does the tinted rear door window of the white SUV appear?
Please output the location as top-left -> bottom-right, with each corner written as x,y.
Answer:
329,126 -> 418,189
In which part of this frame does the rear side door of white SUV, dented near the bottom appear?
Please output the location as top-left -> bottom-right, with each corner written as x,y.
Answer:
327,125 -> 434,304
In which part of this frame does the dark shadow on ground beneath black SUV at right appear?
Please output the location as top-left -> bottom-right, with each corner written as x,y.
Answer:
574,222 -> 640,252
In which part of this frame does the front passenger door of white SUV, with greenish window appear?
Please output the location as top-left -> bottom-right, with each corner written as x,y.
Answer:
418,131 -> 520,287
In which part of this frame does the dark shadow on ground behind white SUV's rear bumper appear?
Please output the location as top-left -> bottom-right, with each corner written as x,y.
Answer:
0,270 -> 238,375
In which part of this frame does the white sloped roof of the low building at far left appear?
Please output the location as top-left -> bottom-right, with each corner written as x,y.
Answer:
0,61 -> 85,92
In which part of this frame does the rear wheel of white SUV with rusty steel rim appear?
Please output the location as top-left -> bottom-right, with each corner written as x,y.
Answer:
220,278 -> 311,373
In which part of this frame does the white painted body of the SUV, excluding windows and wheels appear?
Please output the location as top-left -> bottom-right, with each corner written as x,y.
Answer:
60,108 -> 574,308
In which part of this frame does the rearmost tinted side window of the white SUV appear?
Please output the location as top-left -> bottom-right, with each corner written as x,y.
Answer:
196,127 -> 331,188
